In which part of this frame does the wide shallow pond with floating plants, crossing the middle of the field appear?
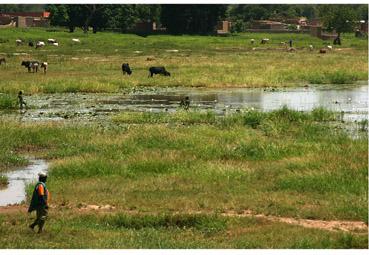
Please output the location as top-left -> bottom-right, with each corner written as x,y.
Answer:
1,82 -> 368,121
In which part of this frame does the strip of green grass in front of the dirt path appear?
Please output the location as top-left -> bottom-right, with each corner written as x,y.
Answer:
0,212 -> 367,249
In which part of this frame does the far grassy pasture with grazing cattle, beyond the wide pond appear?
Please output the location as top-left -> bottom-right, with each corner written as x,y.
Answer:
0,29 -> 368,94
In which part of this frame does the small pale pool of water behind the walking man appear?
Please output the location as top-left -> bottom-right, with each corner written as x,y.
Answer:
0,159 -> 48,206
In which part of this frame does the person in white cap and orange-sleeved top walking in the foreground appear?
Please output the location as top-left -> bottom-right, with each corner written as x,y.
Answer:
28,172 -> 50,233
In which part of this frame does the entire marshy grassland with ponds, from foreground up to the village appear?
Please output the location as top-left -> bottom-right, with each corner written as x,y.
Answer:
0,29 -> 368,248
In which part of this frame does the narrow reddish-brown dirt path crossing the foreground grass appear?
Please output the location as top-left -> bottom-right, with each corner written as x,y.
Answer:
0,204 -> 368,233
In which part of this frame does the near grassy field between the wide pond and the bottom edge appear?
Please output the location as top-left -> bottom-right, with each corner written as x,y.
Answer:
0,108 -> 368,248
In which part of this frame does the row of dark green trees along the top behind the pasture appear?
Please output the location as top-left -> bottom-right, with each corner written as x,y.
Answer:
0,4 -> 368,34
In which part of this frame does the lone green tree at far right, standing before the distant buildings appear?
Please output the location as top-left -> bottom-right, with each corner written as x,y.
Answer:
319,5 -> 355,45
